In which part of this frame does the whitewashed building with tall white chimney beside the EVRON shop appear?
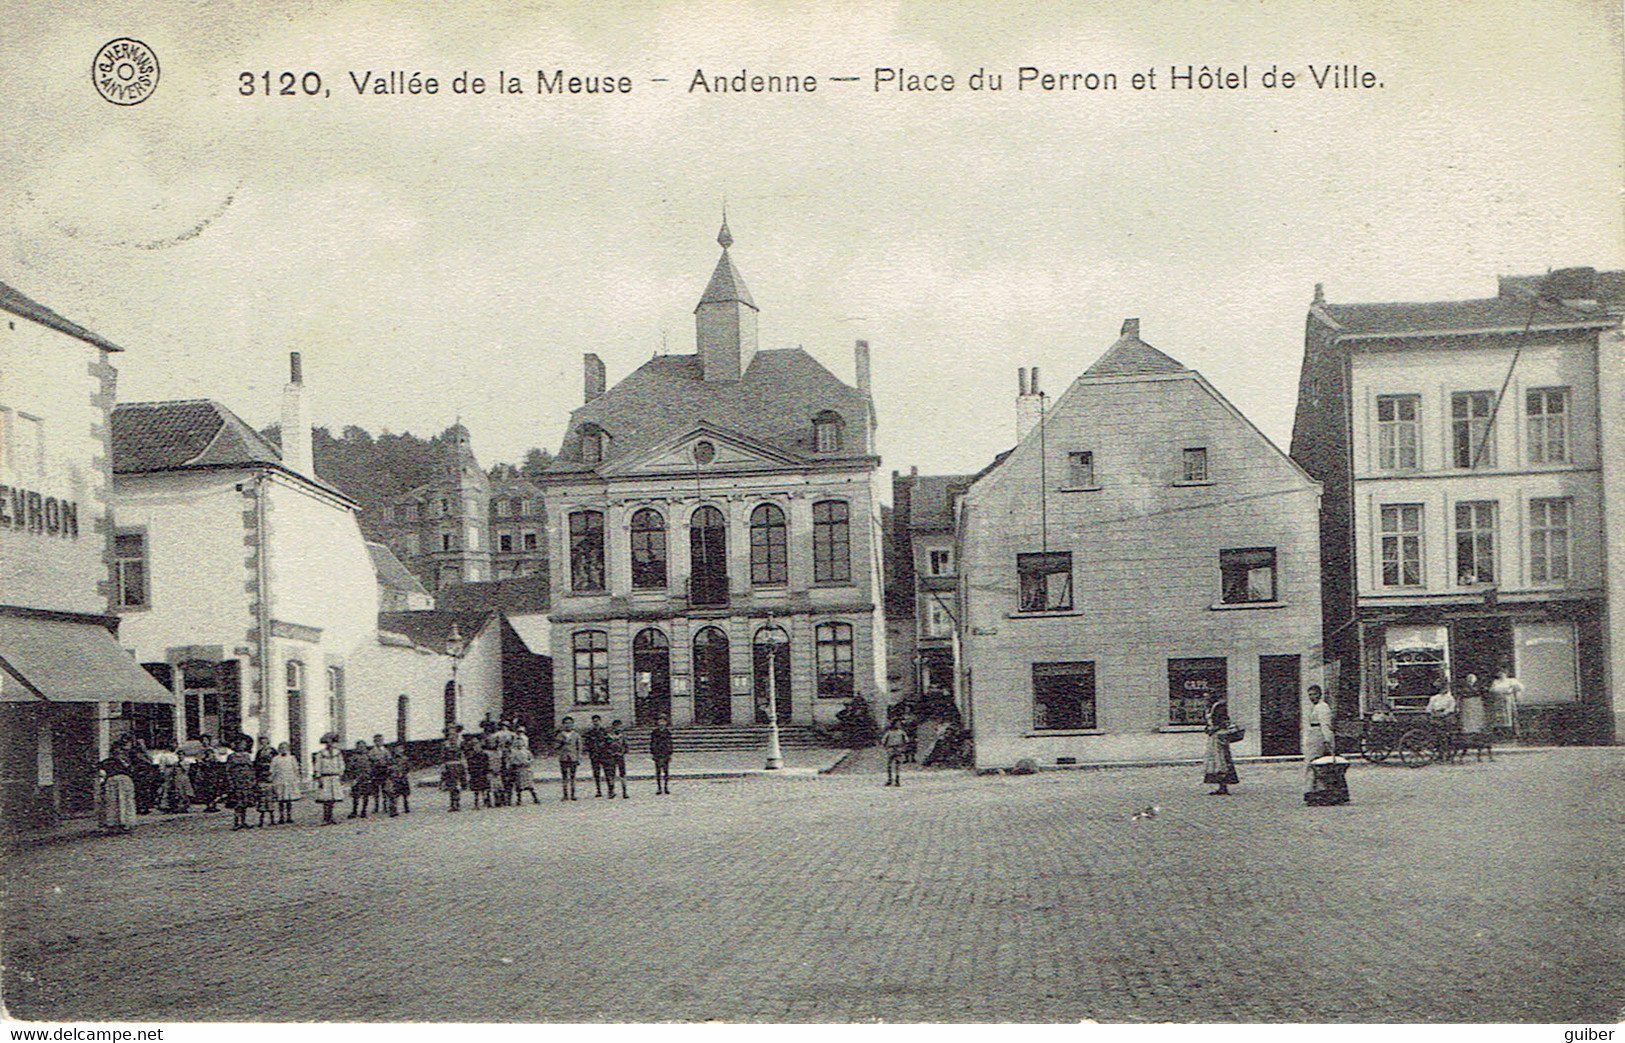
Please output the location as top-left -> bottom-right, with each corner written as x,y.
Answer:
112,353 -> 501,765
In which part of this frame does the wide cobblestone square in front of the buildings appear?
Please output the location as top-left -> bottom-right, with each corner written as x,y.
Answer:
5,749 -> 1625,1024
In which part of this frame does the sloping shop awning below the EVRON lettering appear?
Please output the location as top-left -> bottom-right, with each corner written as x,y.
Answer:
0,616 -> 176,705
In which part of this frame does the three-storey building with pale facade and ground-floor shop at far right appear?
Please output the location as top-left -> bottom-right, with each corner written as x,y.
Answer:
1292,268 -> 1625,742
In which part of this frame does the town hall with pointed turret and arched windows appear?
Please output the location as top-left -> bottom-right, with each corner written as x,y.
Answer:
546,221 -> 886,726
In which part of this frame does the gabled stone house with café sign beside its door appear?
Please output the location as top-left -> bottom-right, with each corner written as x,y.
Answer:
957,320 -> 1321,768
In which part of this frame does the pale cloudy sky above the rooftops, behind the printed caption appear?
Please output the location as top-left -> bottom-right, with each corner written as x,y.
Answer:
0,0 -> 1625,473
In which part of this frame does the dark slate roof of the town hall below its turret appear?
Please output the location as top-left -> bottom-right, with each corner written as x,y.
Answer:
551,348 -> 869,474
